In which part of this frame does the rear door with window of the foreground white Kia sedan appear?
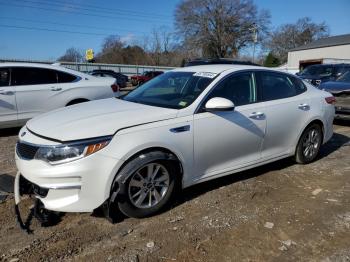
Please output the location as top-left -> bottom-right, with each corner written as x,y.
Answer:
257,71 -> 311,158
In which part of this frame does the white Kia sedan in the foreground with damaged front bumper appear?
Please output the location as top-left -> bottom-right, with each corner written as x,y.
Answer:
15,65 -> 334,217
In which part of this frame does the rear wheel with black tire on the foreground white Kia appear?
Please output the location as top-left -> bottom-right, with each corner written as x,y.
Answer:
295,123 -> 323,164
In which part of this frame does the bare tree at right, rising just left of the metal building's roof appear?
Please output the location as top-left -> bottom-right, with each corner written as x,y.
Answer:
264,17 -> 329,62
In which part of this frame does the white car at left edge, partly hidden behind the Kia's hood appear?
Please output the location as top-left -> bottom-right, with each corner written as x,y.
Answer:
0,63 -> 119,128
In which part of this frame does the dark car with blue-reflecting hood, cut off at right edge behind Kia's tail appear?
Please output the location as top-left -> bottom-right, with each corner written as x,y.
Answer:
319,70 -> 350,120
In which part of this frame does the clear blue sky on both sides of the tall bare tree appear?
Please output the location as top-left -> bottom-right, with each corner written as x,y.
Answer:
0,0 -> 350,61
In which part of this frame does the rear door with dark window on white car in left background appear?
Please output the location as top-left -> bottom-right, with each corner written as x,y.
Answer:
11,67 -> 58,120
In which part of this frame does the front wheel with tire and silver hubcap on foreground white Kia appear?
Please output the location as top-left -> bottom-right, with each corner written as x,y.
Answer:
118,159 -> 176,218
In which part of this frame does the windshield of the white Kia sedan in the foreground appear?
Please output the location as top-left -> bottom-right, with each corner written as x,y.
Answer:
123,72 -> 216,109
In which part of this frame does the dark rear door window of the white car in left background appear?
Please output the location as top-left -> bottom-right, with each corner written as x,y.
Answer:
11,67 -> 57,86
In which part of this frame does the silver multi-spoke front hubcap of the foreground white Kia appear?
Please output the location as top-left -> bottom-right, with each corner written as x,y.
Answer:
128,163 -> 170,208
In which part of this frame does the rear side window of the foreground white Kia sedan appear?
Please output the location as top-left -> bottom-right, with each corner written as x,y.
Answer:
259,72 -> 306,101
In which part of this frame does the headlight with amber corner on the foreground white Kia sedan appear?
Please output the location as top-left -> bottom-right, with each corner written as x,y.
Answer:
34,136 -> 112,165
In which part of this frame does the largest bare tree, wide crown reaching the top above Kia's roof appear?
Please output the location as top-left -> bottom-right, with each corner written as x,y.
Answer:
175,0 -> 270,57
